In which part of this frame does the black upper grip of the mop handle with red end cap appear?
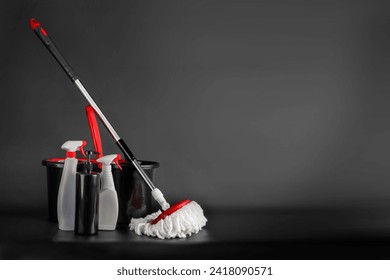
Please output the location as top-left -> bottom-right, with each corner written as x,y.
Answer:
30,18 -> 78,82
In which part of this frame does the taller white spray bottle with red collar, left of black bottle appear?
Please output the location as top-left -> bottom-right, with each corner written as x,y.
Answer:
57,141 -> 87,231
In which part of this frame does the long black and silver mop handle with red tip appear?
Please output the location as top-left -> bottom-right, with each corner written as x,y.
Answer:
30,19 -> 161,192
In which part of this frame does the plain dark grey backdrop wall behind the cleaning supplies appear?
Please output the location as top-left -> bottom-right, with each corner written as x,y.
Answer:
0,0 -> 390,210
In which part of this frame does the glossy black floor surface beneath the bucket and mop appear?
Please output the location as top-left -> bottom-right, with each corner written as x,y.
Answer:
0,208 -> 390,260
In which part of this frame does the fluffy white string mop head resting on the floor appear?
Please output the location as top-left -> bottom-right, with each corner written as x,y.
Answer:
129,201 -> 207,239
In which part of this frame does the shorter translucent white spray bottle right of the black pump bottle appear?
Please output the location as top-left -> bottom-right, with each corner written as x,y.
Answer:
97,155 -> 122,230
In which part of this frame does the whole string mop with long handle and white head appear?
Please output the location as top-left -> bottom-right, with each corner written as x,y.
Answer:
30,19 -> 207,239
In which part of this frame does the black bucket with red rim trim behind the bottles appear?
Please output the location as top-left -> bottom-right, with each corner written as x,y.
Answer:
42,158 -> 159,225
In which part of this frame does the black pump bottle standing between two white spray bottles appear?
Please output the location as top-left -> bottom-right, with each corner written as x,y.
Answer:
75,151 -> 100,235
